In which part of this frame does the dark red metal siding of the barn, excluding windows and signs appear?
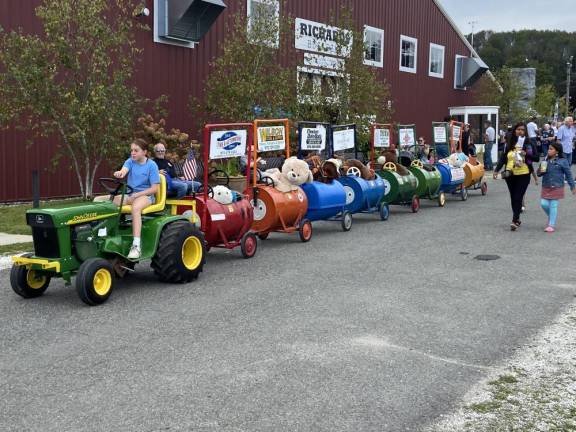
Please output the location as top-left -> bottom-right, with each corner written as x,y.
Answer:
0,0 -> 473,202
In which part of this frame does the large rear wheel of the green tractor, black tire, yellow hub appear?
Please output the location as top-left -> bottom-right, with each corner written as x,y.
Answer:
151,220 -> 206,283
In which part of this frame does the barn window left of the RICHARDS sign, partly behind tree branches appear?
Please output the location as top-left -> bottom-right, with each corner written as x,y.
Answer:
246,0 -> 280,48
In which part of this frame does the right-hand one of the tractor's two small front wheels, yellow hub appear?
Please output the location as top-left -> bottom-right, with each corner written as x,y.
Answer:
76,258 -> 114,306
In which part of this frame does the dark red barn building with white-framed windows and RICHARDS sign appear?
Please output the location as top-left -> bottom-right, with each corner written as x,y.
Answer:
0,0 -> 490,202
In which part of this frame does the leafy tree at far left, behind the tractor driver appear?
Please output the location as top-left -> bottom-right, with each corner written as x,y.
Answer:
0,0 -> 148,198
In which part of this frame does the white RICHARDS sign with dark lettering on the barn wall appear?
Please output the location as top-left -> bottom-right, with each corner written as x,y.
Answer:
294,18 -> 352,57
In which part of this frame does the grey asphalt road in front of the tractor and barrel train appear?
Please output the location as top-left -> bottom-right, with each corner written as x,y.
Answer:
0,176 -> 576,432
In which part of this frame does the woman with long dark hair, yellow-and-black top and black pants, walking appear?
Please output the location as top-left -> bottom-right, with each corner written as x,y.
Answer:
493,123 -> 531,231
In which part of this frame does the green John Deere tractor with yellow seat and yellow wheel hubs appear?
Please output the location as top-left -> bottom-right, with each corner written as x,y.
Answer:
10,175 -> 206,306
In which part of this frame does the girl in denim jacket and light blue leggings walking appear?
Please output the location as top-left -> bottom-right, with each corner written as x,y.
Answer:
538,143 -> 576,233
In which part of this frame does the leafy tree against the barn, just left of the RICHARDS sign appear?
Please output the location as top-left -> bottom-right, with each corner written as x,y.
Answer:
190,3 -> 295,124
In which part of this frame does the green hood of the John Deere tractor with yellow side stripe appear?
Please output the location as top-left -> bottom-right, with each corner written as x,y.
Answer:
26,201 -> 119,228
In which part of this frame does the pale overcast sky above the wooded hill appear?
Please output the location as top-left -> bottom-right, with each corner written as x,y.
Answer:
439,0 -> 576,34
